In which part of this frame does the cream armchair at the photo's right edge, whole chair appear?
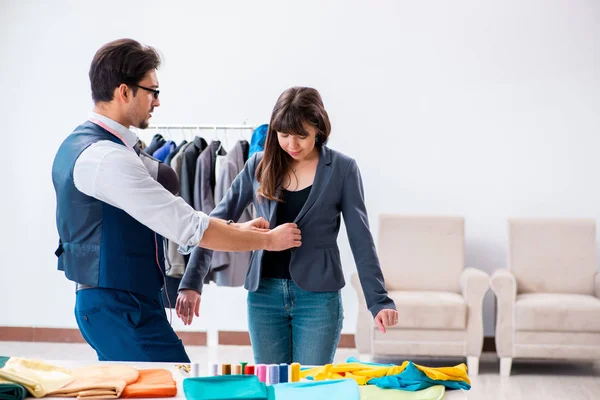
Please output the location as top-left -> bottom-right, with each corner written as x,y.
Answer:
491,219 -> 600,376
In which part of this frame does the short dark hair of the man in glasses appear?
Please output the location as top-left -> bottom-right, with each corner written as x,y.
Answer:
90,39 -> 160,103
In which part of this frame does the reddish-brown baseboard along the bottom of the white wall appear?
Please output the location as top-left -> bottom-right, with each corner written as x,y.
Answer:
0,326 -> 496,352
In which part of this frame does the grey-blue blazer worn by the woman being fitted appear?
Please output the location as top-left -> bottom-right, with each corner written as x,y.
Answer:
179,146 -> 396,316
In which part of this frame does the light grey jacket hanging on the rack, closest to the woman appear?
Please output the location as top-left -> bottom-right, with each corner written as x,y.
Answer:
211,141 -> 252,286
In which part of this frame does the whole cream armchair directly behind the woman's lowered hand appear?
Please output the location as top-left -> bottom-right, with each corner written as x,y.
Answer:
352,215 -> 489,376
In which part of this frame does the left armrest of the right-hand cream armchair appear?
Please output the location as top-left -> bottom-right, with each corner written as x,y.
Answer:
491,268 -> 517,358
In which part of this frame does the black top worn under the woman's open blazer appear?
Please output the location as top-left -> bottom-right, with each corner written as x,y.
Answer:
261,186 -> 312,279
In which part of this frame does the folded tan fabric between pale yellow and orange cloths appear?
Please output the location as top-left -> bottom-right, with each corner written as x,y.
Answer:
49,364 -> 139,399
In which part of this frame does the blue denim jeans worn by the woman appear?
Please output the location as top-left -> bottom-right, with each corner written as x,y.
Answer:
248,279 -> 344,365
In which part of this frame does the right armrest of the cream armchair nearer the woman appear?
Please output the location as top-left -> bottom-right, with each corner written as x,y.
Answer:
460,268 -> 490,357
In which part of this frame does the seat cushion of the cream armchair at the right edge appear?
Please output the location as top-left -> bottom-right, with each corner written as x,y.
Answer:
515,293 -> 600,332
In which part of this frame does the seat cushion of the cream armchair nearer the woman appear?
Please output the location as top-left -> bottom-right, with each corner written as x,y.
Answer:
389,291 -> 467,329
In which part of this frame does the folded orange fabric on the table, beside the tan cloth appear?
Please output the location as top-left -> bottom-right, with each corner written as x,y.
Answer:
121,369 -> 177,398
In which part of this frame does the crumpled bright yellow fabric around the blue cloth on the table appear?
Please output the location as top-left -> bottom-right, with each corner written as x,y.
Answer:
300,361 -> 471,385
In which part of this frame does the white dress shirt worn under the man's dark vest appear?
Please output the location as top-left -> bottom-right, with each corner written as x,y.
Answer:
73,112 -> 210,254
